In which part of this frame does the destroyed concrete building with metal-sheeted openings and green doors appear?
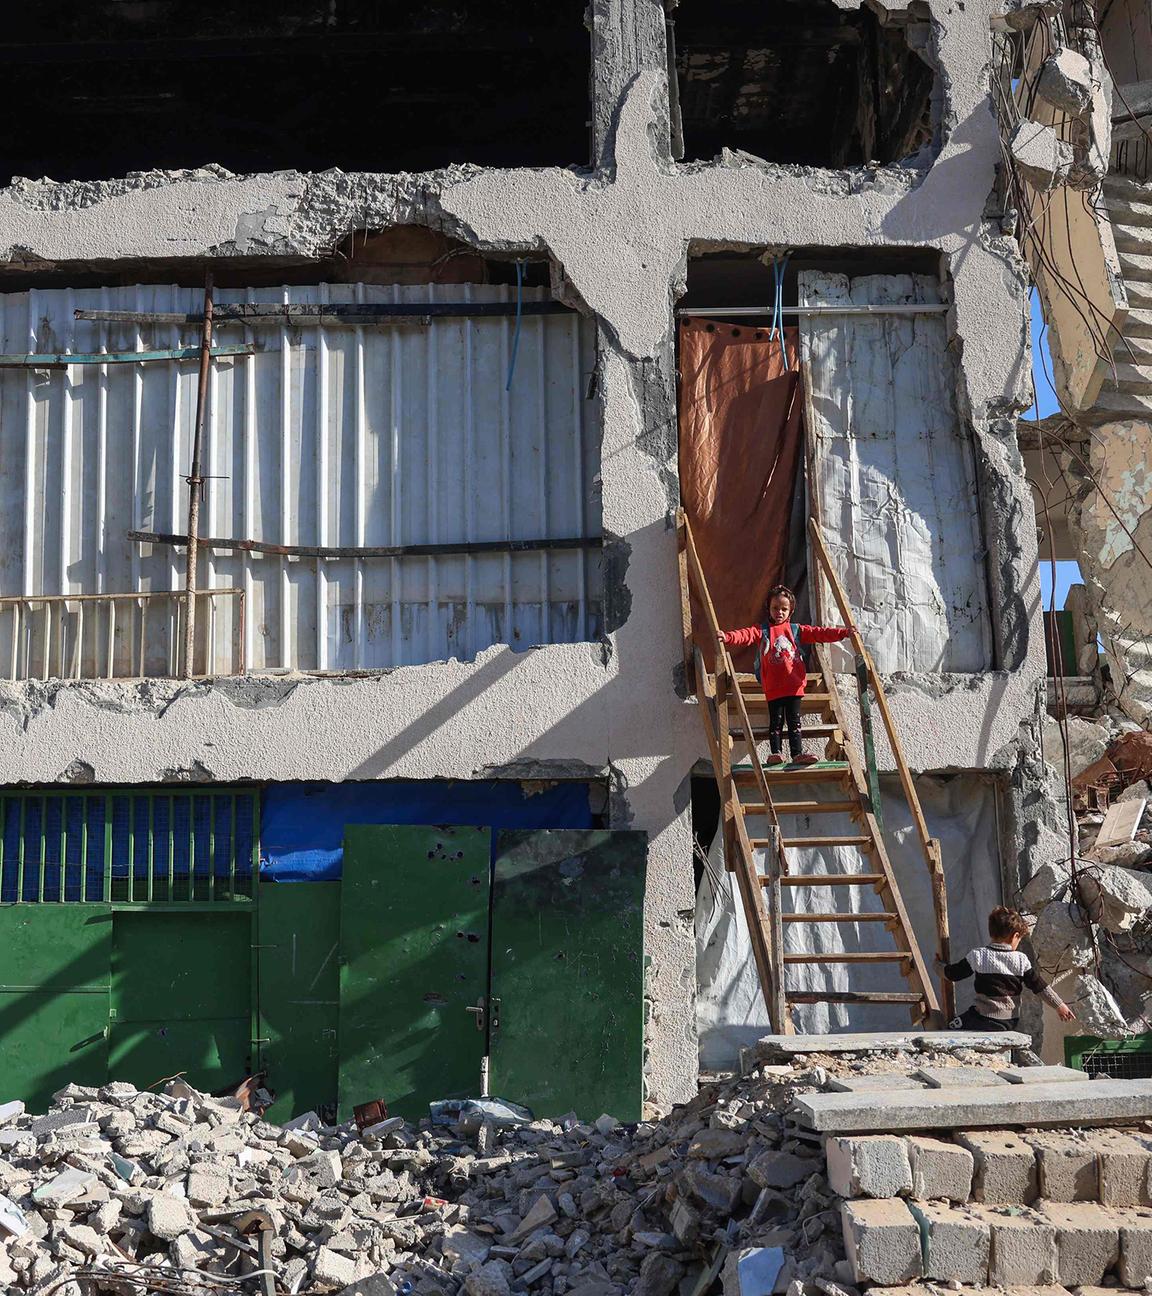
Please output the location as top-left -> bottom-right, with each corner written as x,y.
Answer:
0,0 -> 1131,1120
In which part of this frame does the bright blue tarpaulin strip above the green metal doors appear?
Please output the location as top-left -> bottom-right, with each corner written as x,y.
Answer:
260,779 -> 592,883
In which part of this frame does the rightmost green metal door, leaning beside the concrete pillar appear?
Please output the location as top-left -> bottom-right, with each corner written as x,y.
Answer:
491,831 -> 648,1121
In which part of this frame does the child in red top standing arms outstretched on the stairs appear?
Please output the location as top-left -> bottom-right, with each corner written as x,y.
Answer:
723,584 -> 851,765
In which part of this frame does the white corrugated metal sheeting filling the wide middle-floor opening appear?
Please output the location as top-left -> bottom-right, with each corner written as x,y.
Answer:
0,284 -> 601,675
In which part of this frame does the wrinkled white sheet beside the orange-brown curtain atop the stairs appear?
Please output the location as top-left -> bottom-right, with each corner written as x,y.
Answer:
800,271 -> 993,673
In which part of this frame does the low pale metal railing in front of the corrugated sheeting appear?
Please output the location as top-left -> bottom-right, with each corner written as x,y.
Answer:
0,587 -> 246,680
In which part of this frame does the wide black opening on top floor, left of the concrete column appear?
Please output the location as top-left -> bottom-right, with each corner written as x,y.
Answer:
0,0 -> 590,184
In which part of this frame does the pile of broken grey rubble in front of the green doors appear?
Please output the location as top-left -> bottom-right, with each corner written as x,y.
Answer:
0,1061 -> 870,1296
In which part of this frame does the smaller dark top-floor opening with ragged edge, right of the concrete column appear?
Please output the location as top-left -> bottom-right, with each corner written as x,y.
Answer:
669,0 -> 936,167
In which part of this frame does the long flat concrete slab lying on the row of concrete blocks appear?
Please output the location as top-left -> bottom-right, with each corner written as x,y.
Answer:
792,1080 -> 1152,1134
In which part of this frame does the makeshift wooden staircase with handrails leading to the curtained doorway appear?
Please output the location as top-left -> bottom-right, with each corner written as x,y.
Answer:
678,509 -> 952,1033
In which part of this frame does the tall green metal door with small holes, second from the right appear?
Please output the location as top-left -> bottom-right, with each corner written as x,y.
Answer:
340,824 -> 491,1120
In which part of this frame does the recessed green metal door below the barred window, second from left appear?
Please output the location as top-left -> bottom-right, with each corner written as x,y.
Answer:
108,905 -> 254,1090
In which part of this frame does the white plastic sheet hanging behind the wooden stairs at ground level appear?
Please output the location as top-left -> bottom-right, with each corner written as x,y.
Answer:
696,774 -> 1002,1070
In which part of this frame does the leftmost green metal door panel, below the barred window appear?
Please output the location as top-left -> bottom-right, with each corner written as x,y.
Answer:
0,905 -> 111,1111
